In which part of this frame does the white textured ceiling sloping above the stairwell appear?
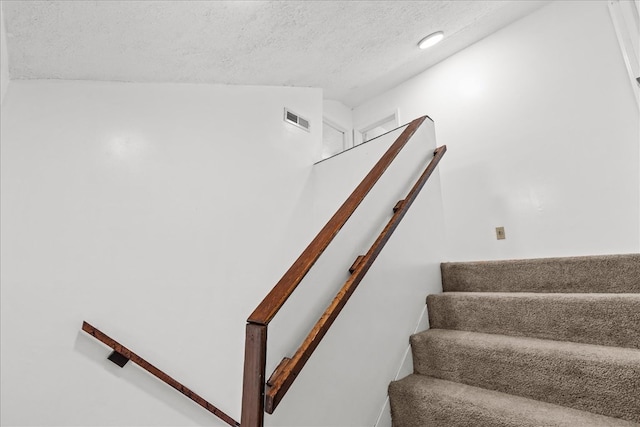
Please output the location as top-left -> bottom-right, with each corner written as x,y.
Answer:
2,0 -> 546,106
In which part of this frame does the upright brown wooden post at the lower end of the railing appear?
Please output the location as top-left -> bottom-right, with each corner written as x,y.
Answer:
240,323 -> 267,427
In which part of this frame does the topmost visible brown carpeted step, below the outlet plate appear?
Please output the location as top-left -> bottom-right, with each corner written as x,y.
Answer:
441,254 -> 640,293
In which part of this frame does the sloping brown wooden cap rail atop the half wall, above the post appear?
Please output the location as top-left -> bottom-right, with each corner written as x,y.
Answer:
247,116 -> 427,325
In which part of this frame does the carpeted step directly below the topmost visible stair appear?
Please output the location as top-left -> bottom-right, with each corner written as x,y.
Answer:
427,292 -> 640,349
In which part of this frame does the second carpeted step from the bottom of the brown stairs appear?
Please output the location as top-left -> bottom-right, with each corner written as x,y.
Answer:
411,330 -> 640,423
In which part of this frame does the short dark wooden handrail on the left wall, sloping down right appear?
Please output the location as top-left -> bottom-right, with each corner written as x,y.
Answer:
82,322 -> 240,427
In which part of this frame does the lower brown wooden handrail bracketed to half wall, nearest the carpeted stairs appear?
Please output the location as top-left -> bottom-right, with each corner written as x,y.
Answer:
265,145 -> 447,414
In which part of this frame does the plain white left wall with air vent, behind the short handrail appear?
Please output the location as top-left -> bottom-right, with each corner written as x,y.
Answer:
0,81 -> 322,426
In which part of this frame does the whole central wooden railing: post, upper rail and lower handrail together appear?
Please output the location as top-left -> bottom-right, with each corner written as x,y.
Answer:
241,116 -> 446,427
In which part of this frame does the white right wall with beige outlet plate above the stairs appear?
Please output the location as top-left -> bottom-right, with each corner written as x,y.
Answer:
354,1 -> 640,260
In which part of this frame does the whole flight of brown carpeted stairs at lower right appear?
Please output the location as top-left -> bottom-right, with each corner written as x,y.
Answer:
389,254 -> 640,427
